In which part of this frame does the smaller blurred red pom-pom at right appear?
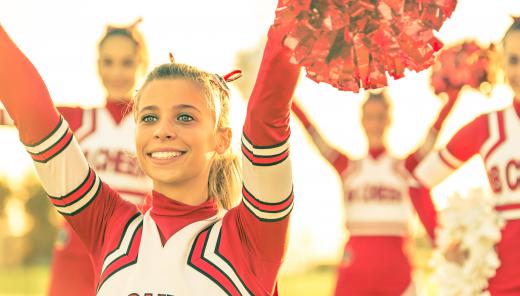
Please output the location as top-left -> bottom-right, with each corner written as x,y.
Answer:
431,41 -> 498,94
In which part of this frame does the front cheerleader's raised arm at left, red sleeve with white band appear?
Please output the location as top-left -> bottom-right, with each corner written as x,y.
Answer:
0,26 -> 135,262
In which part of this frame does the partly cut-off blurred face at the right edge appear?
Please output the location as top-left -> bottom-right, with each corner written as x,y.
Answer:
504,30 -> 520,100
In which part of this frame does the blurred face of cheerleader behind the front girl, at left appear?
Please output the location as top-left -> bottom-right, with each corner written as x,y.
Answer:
98,35 -> 140,99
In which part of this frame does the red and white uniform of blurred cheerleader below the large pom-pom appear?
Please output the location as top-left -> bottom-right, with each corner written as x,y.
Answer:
293,103 -> 436,295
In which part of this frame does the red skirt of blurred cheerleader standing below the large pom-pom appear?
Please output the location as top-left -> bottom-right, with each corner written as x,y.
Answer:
335,236 -> 411,296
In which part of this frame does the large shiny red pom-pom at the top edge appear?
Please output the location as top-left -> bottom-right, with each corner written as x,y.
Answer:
274,0 -> 457,92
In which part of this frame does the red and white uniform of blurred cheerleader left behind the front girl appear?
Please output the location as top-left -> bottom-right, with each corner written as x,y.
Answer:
0,81 -> 152,296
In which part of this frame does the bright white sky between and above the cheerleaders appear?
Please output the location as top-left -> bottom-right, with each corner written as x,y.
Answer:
0,0 -> 520,269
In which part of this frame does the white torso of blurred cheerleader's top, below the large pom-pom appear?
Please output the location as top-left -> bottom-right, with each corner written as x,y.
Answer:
342,153 -> 414,236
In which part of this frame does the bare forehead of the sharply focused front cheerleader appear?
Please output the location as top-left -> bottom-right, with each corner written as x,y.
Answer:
138,78 -> 209,111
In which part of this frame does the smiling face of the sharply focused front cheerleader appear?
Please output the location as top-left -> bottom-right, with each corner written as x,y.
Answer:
136,78 -> 229,197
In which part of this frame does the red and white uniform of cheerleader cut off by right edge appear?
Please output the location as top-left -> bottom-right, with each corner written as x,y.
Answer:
415,100 -> 520,295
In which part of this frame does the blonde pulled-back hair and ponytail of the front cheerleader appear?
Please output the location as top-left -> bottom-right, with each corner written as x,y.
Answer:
133,63 -> 241,209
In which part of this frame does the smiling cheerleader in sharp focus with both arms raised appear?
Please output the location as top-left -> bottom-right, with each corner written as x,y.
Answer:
0,3 -> 299,295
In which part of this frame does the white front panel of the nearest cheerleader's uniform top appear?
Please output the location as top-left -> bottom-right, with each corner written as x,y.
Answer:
97,213 -> 236,296
